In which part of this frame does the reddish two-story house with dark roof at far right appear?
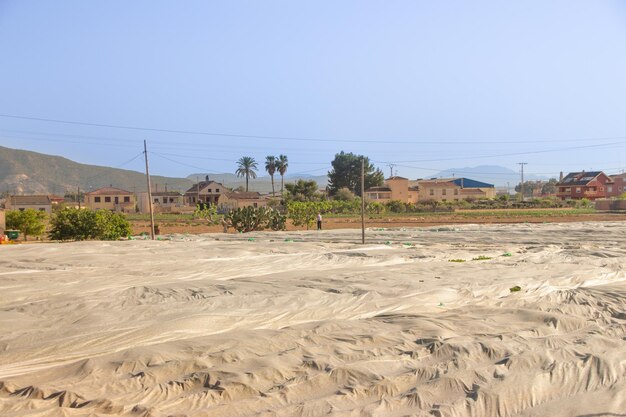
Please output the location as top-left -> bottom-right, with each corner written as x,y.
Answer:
556,171 -> 617,200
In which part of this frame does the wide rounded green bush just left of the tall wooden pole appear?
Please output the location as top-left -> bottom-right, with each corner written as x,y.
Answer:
50,207 -> 131,240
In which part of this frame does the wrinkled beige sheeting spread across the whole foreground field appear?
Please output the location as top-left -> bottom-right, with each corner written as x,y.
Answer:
0,222 -> 626,417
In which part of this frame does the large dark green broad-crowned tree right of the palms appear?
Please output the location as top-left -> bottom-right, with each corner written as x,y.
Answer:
328,151 -> 385,196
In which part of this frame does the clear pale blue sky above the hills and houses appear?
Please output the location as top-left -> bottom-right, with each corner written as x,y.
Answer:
0,0 -> 626,184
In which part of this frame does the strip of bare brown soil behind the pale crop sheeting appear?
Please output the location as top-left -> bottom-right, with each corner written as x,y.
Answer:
132,209 -> 626,234
